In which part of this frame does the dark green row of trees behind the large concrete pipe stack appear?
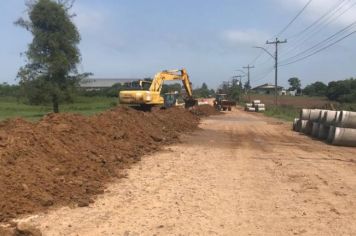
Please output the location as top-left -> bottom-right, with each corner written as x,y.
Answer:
303,78 -> 356,103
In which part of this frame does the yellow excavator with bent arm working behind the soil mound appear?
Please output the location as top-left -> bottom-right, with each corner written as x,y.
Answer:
119,69 -> 197,111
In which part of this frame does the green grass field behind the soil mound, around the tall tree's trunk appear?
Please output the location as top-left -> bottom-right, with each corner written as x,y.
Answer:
0,97 -> 117,121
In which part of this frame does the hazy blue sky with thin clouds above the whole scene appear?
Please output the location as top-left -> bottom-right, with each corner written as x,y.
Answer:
0,0 -> 356,88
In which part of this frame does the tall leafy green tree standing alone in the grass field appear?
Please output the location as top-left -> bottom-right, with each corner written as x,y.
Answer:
15,0 -> 88,113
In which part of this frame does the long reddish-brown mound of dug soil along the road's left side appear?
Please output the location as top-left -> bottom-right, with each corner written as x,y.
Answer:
0,107 -> 214,222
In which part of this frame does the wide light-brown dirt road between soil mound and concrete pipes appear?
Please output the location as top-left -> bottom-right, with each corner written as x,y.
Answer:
20,110 -> 356,236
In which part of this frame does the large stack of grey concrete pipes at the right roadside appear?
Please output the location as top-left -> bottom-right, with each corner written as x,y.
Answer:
293,109 -> 356,147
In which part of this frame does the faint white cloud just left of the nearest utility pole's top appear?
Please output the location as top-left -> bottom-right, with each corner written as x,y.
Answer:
223,29 -> 269,46
